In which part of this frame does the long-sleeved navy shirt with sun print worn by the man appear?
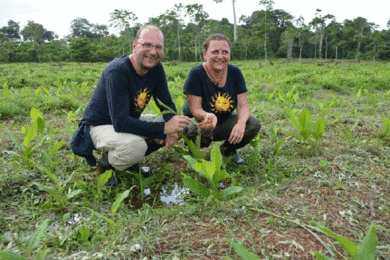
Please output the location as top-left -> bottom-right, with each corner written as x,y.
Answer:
82,55 -> 176,139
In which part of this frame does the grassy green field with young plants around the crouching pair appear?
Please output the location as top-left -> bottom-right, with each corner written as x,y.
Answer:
0,60 -> 390,259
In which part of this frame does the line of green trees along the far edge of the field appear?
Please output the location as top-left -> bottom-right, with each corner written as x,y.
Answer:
0,0 -> 390,63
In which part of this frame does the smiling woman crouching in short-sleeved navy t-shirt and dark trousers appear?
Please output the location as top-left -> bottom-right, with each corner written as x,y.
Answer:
183,34 -> 261,163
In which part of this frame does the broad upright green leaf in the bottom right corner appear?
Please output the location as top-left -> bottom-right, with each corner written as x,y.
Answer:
353,225 -> 378,260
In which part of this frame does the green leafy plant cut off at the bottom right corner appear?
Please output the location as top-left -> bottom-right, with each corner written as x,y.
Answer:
315,225 -> 378,260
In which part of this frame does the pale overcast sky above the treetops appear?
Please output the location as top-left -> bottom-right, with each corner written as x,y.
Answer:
0,0 -> 390,38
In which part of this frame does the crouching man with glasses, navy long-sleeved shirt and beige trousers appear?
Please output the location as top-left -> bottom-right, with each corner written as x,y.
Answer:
71,25 -> 191,186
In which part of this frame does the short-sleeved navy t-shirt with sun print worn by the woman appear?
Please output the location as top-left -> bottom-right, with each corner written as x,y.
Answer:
183,64 -> 247,121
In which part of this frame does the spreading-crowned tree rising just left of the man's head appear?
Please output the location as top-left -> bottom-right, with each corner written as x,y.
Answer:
110,9 -> 138,55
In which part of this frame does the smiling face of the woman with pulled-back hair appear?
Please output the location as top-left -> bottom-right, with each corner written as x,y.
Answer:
203,40 -> 230,71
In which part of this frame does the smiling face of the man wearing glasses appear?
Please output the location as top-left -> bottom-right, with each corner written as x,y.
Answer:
133,29 -> 164,70
